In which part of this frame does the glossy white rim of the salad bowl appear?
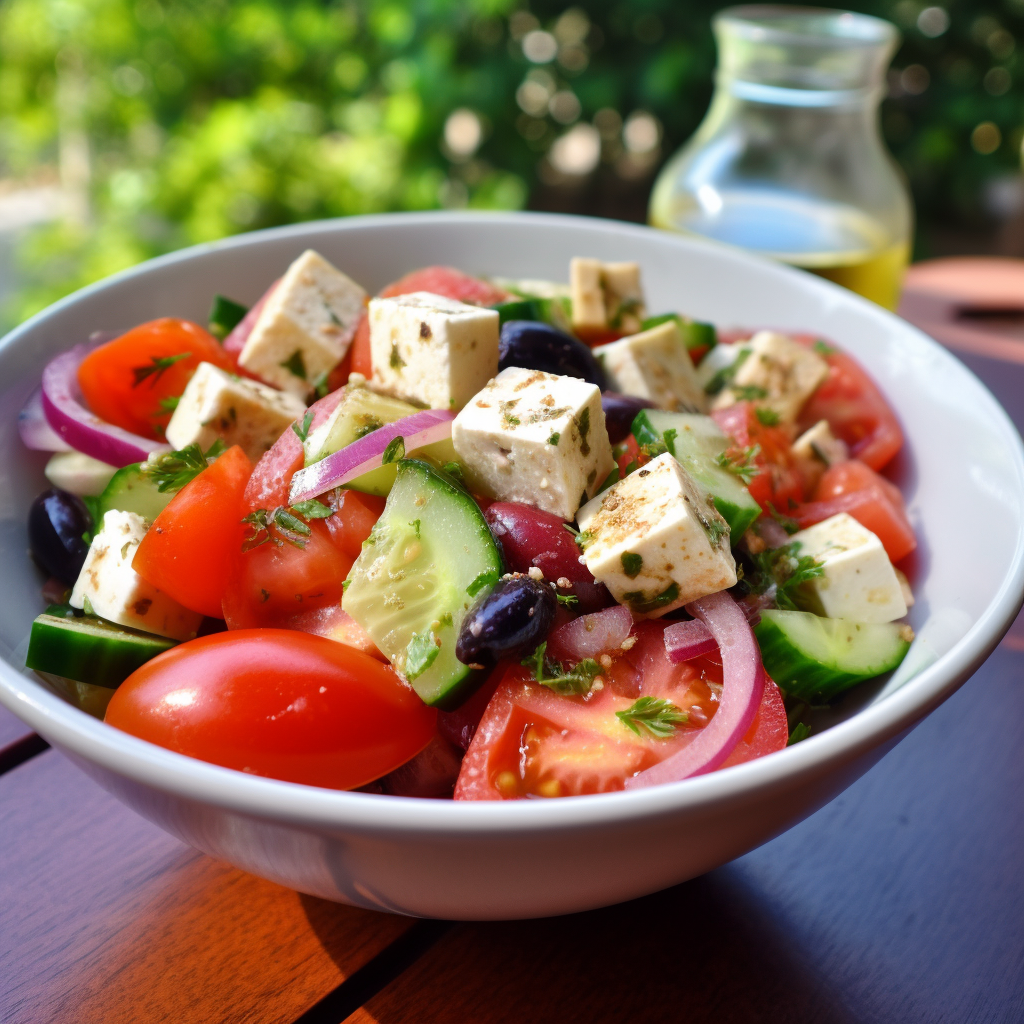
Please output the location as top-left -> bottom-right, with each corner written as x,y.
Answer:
0,211 -> 1024,839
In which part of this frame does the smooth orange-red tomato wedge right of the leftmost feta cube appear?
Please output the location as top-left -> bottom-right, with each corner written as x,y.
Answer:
132,444 -> 253,618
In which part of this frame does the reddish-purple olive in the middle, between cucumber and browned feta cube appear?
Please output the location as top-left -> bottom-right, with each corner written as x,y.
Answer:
483,502 -> 611,611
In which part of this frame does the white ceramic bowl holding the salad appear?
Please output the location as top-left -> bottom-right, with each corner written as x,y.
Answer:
0,213 -> 1024,919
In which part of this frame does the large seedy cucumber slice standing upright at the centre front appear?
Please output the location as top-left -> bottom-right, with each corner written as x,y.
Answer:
341,459 -> 502,709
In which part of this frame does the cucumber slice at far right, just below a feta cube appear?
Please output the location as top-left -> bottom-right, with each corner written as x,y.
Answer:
754,610 -> 912,701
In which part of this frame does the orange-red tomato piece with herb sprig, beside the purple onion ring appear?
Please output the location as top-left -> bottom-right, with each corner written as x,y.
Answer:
78,316 -> 234,440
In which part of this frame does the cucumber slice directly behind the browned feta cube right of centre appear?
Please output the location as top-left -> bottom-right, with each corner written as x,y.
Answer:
633,409 -> 761,543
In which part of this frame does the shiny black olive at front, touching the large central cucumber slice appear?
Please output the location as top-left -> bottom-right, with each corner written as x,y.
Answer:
455,575 -> 558,665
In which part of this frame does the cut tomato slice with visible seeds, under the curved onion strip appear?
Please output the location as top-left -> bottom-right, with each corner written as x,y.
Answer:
455,622 -> 788,800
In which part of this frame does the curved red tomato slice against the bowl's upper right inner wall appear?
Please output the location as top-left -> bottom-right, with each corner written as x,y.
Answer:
796,336 -> 903,469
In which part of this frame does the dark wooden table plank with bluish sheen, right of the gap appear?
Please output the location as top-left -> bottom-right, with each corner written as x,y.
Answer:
348,638 -> 1024,1024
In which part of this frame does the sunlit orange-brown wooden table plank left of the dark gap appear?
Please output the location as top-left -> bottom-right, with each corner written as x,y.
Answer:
0,752 -> 412,1024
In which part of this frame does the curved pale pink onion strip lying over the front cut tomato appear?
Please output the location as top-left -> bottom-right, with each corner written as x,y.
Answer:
626,591 -> 765,790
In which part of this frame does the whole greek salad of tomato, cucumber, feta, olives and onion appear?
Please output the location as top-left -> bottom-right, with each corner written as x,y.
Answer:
19,251 -> 915,800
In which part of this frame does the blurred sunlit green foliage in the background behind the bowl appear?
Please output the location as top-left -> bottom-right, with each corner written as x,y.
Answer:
0,0 -> 1024,318
